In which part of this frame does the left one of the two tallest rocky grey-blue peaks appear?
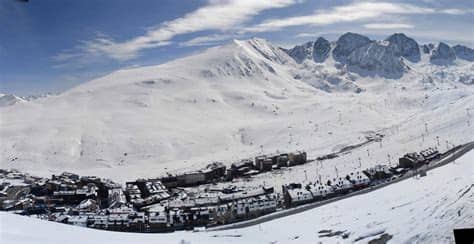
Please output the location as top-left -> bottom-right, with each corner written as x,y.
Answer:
333,32 -> 371,63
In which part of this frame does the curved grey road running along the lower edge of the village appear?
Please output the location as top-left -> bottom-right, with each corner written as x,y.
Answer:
206,141 -> 474,231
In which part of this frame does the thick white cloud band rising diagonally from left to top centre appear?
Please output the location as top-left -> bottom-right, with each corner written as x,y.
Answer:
56,0 -> 298,61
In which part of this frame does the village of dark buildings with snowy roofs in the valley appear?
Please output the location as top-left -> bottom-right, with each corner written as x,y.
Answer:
0,146 -> 460,233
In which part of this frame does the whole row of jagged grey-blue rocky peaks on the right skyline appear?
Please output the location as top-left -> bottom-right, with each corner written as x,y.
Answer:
286,32 -> 474,79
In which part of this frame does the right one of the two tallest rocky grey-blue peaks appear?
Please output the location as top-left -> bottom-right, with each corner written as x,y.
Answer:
385,33 -> 420,62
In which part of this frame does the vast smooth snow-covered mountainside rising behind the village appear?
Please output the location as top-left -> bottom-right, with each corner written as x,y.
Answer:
0,34 -> 474,180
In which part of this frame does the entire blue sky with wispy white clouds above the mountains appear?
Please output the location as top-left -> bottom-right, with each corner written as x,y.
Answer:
0,0 -> 474,95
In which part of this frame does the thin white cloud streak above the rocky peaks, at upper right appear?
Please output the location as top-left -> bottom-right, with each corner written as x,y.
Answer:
246,2 -> 464,32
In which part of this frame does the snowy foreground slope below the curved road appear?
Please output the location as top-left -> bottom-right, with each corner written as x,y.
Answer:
0,150 -> 474,244
